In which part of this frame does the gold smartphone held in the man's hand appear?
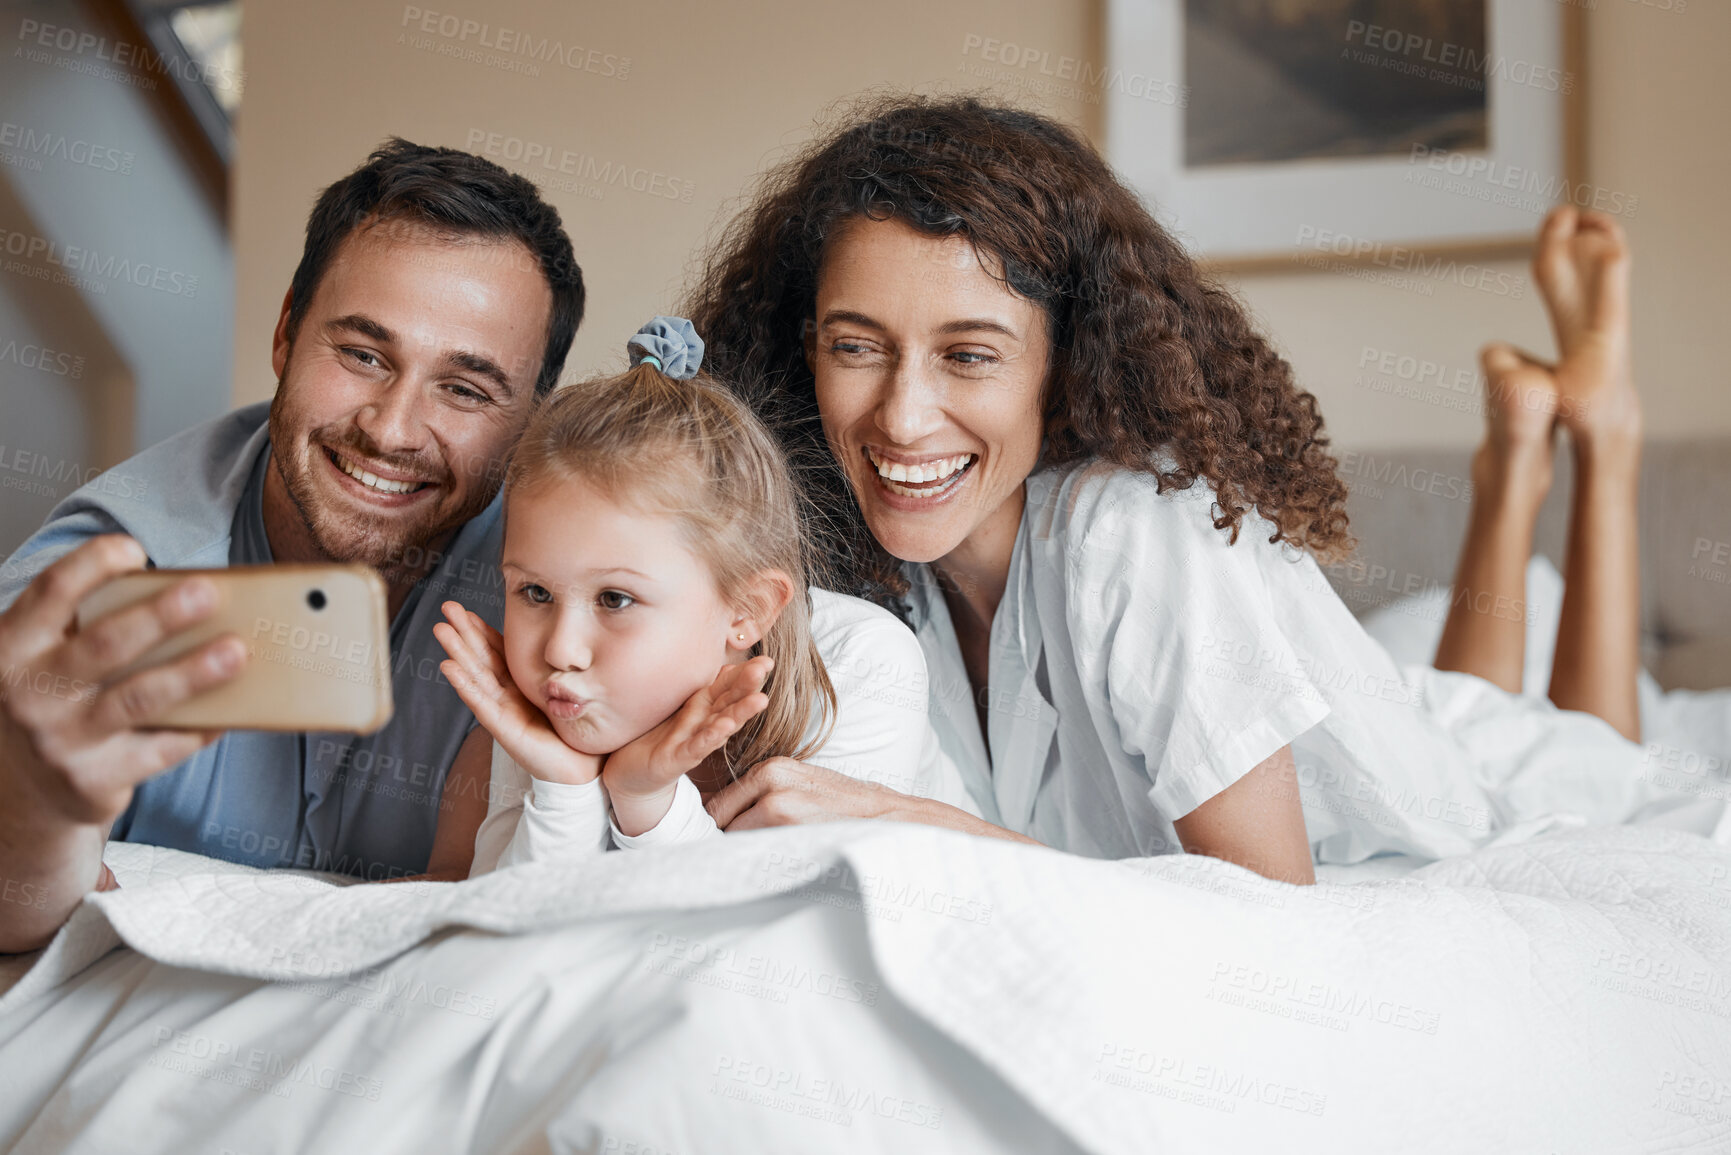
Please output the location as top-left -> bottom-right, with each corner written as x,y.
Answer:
78,565 -> 391,734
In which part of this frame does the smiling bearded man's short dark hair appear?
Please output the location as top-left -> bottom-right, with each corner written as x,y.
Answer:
289,137 -> 583,397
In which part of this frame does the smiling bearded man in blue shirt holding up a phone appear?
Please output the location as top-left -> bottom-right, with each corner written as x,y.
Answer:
0,140 -> 583,952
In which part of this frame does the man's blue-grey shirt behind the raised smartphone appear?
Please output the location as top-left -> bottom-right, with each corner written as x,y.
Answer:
0,403 -> 505,880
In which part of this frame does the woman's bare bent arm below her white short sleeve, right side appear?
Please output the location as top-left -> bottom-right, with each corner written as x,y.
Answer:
1172,746 -> 1316,885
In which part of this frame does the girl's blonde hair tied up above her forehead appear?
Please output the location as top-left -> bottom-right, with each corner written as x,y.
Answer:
505,362 -> 836,778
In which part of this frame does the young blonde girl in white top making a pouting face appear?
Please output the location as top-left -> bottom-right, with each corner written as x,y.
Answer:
425,317 -> 964,876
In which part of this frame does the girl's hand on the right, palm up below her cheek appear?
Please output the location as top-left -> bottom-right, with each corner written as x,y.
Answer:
601,655 -> 775,836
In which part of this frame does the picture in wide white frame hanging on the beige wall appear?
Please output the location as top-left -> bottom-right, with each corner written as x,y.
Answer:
1106,0 -> 1603,265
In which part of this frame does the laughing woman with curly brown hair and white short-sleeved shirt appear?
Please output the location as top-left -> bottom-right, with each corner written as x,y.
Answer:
691,99 -> 1661,881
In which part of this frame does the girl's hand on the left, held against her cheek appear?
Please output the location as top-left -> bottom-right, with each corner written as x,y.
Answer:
433,601 -> 601,786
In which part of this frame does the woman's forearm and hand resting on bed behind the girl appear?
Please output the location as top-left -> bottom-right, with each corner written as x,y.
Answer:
708,758 -> 1040,847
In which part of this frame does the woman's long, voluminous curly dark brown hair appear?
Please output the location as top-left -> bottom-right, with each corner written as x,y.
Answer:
687,95 -> 1352,616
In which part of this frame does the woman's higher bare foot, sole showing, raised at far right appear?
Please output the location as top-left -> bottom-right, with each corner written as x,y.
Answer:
1532,204 -> 1641,448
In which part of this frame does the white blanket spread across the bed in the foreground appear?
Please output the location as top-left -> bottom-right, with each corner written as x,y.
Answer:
0,824 -> 1731,1155
